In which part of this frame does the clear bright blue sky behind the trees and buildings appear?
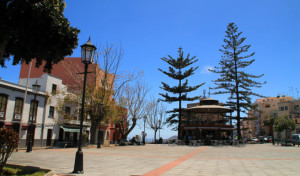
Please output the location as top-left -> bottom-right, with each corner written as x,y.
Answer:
0,0 -> 300,138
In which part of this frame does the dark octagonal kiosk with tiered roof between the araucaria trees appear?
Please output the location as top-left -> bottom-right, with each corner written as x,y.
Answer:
179,98 -> 234,145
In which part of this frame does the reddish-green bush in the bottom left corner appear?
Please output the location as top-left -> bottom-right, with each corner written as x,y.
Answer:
0,127 -> 19,175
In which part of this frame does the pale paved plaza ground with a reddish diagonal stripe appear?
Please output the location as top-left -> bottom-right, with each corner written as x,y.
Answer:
8,144 -> 300,176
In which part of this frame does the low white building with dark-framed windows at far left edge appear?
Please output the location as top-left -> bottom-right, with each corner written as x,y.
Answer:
0,80 -> 47,147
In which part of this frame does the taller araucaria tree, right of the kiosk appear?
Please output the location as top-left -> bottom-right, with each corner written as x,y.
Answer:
210,23 -> 266,140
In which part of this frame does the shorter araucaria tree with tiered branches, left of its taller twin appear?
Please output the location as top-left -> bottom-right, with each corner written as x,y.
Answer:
158,48 -> 204,139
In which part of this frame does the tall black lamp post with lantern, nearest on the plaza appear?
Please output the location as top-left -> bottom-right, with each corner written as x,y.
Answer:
73,38 -> 96,174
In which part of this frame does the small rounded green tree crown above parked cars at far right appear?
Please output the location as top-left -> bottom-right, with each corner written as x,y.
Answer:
274,115 -> 296,132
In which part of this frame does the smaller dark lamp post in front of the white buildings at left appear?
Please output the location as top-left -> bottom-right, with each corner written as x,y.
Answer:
26,80 -> 41,152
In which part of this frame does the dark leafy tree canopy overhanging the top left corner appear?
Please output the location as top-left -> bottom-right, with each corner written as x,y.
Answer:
0,0 -> 79,71
